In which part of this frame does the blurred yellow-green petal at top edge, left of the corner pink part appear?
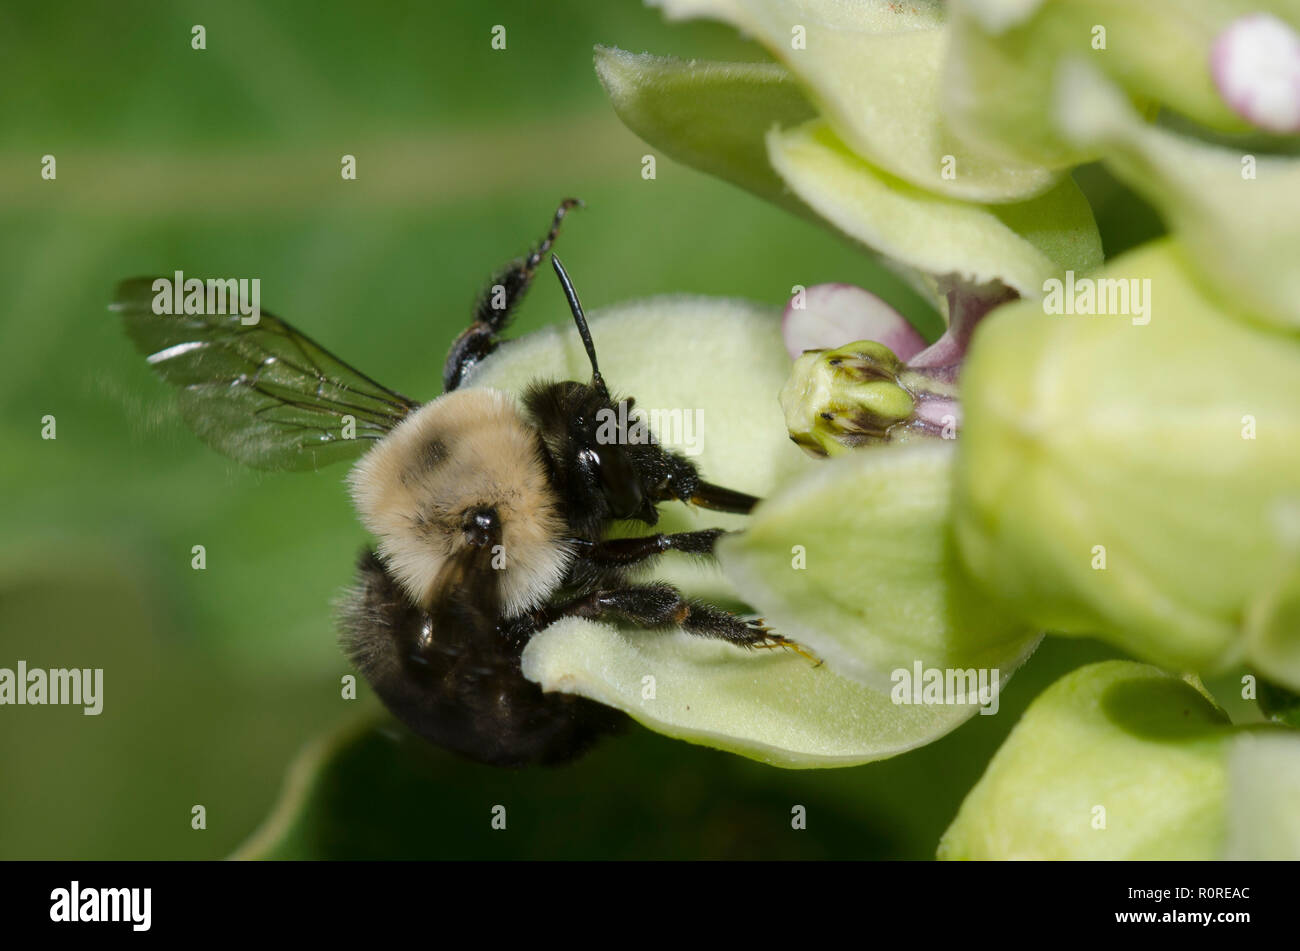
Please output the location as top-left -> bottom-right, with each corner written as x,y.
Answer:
943,0 -> 1261,169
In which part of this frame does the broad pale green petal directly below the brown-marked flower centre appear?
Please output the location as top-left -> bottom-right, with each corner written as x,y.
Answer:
719,442 -> 1039,691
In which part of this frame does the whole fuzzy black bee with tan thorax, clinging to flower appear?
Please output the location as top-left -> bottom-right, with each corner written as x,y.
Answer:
111,199 -> 797,767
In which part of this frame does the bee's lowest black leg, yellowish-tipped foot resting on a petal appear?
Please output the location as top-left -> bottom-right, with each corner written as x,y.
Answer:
512,583 -> 822,664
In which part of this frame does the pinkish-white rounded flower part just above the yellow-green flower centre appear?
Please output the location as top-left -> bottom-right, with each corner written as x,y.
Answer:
781,285 -> 926,360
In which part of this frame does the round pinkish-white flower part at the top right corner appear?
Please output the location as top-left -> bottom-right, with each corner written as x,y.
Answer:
1210,13 -> 1300,133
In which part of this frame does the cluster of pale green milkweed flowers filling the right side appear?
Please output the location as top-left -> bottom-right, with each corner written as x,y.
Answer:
447,0 -> 1300,815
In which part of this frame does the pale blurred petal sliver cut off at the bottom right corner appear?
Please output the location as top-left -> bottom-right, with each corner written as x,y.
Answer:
1223,730 -> 1300,861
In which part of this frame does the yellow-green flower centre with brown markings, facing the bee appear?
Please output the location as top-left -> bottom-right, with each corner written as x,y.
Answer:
781,340 -> 917,456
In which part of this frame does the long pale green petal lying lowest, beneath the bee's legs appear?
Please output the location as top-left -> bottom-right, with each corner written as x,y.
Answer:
514,618 -> 979,768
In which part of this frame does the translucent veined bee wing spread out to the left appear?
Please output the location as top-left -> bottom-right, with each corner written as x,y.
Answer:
111,278 -> 420,470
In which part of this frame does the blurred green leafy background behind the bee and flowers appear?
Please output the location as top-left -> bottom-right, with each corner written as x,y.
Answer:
0,0 -> 1196,859
